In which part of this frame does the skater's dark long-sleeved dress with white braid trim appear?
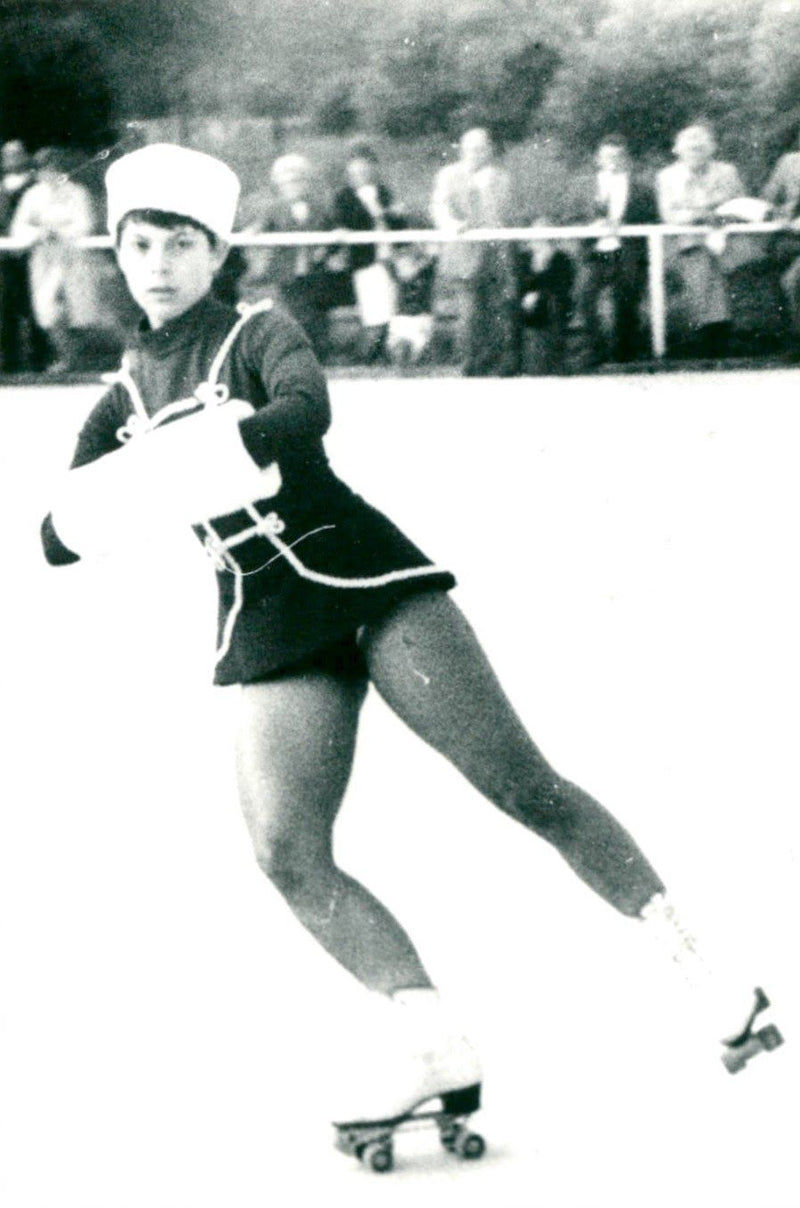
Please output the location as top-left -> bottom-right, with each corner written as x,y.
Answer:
42,297 -> 456,684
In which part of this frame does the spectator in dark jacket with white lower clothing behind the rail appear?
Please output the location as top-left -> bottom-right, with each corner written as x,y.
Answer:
334,143 -> 402,365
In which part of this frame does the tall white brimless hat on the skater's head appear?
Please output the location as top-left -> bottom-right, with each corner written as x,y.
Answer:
105,143 -> 239,239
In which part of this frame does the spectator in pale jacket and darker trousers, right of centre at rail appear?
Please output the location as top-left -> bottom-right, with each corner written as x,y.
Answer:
431,127 -> 518,376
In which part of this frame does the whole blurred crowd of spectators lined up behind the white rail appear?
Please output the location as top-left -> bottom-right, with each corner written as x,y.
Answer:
0,122 -> 800,376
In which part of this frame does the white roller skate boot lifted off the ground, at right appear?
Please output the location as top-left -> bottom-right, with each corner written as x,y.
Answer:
642,894 -> 783,1074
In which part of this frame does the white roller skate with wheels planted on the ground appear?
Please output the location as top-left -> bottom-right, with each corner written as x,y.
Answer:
335,989 -> 485,1172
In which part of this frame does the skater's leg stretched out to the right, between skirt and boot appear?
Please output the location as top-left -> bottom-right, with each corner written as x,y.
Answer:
363,592 -> 663,917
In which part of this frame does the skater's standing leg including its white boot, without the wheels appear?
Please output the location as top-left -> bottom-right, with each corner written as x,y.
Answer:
237,670 -> 481,1122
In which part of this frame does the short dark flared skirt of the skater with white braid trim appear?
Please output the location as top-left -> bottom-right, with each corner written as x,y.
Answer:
206,476 -> 456,685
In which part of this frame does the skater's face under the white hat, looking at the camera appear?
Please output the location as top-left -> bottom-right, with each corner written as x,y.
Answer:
117,219 -> 227,329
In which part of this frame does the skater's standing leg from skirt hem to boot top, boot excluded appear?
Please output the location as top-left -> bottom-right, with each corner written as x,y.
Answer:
237,672 -> 431,994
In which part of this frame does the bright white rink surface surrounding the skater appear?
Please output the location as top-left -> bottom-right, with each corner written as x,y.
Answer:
0,371 -> 800,1208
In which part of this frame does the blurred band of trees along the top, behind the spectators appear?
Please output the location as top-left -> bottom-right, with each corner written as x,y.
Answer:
0,0 -> 800,201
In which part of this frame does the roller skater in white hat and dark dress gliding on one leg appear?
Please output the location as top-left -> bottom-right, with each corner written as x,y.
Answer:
42,145 -> 783,1157
